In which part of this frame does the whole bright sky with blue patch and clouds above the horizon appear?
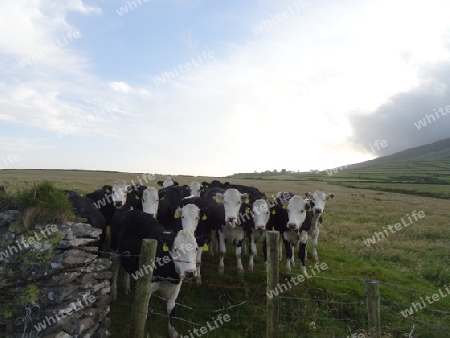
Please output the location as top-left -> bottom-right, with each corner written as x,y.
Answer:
0,0 -> 450,177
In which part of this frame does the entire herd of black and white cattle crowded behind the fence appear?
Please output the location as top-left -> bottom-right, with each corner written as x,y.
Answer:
68,178 -> 333,337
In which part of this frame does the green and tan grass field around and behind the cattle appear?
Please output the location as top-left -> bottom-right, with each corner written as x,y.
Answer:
0,169 -> 450,337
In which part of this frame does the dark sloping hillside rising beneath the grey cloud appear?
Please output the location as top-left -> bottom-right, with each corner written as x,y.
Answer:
348,138 -> 450,169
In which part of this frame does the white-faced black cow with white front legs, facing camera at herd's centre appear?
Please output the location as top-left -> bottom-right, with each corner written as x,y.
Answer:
204,188 -> 250,273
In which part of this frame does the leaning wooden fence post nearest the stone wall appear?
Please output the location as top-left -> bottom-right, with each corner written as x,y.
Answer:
130,238 -> 158,338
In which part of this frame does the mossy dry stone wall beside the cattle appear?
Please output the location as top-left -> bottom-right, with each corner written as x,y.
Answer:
0,210 -> 112,338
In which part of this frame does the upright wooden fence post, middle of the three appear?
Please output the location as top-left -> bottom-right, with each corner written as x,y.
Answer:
266,231 -> 280,338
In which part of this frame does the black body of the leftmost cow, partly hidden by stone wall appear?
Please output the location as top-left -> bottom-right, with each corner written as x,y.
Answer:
66,191 -> 106,251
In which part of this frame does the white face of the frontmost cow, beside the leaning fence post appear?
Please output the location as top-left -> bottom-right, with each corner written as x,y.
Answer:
171,229 -> 198,279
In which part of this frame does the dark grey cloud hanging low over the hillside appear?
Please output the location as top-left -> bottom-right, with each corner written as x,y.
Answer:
350,62 -> 450,156
